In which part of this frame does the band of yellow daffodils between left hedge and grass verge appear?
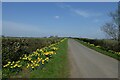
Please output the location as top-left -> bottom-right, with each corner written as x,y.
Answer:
3,39 -> 66,74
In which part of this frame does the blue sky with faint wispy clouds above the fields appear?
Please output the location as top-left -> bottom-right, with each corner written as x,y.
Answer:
2,2 -> 117,38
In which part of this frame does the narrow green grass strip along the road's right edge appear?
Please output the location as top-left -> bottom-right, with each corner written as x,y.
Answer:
75,39 -> 120,61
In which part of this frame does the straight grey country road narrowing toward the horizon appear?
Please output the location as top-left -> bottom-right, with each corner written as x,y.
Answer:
68,39 -> 118,78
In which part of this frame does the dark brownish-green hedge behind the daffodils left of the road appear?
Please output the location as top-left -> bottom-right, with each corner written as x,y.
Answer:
2,37 -> 61,65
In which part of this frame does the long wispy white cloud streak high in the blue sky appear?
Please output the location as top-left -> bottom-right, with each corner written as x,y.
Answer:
57,3 -> 102,18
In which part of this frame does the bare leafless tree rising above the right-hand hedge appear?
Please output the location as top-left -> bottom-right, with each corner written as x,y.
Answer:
101,10 -> 119,40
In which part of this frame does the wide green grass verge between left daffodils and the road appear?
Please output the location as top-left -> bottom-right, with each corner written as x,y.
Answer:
30,39 -> 69,78
